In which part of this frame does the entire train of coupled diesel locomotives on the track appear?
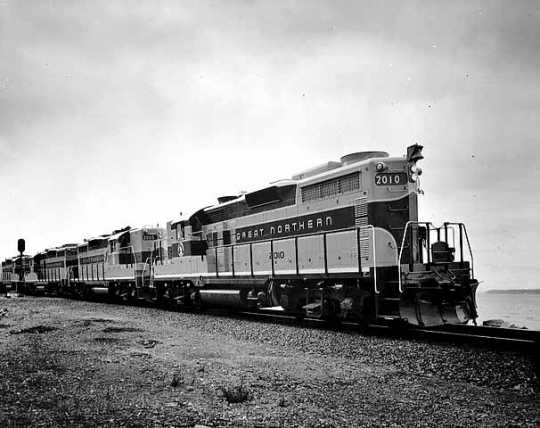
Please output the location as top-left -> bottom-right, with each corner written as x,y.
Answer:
1,144 -> 478,327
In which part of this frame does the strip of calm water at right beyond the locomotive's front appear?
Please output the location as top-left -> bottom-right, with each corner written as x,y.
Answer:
476,293 -> 540,330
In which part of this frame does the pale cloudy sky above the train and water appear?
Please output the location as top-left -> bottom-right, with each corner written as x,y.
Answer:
0,0 -> 540,289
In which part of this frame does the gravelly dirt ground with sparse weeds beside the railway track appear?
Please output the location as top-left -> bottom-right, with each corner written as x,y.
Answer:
0,297 -> 540,428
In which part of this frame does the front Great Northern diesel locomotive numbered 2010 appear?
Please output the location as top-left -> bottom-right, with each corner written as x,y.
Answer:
153,145 -> 478,326
